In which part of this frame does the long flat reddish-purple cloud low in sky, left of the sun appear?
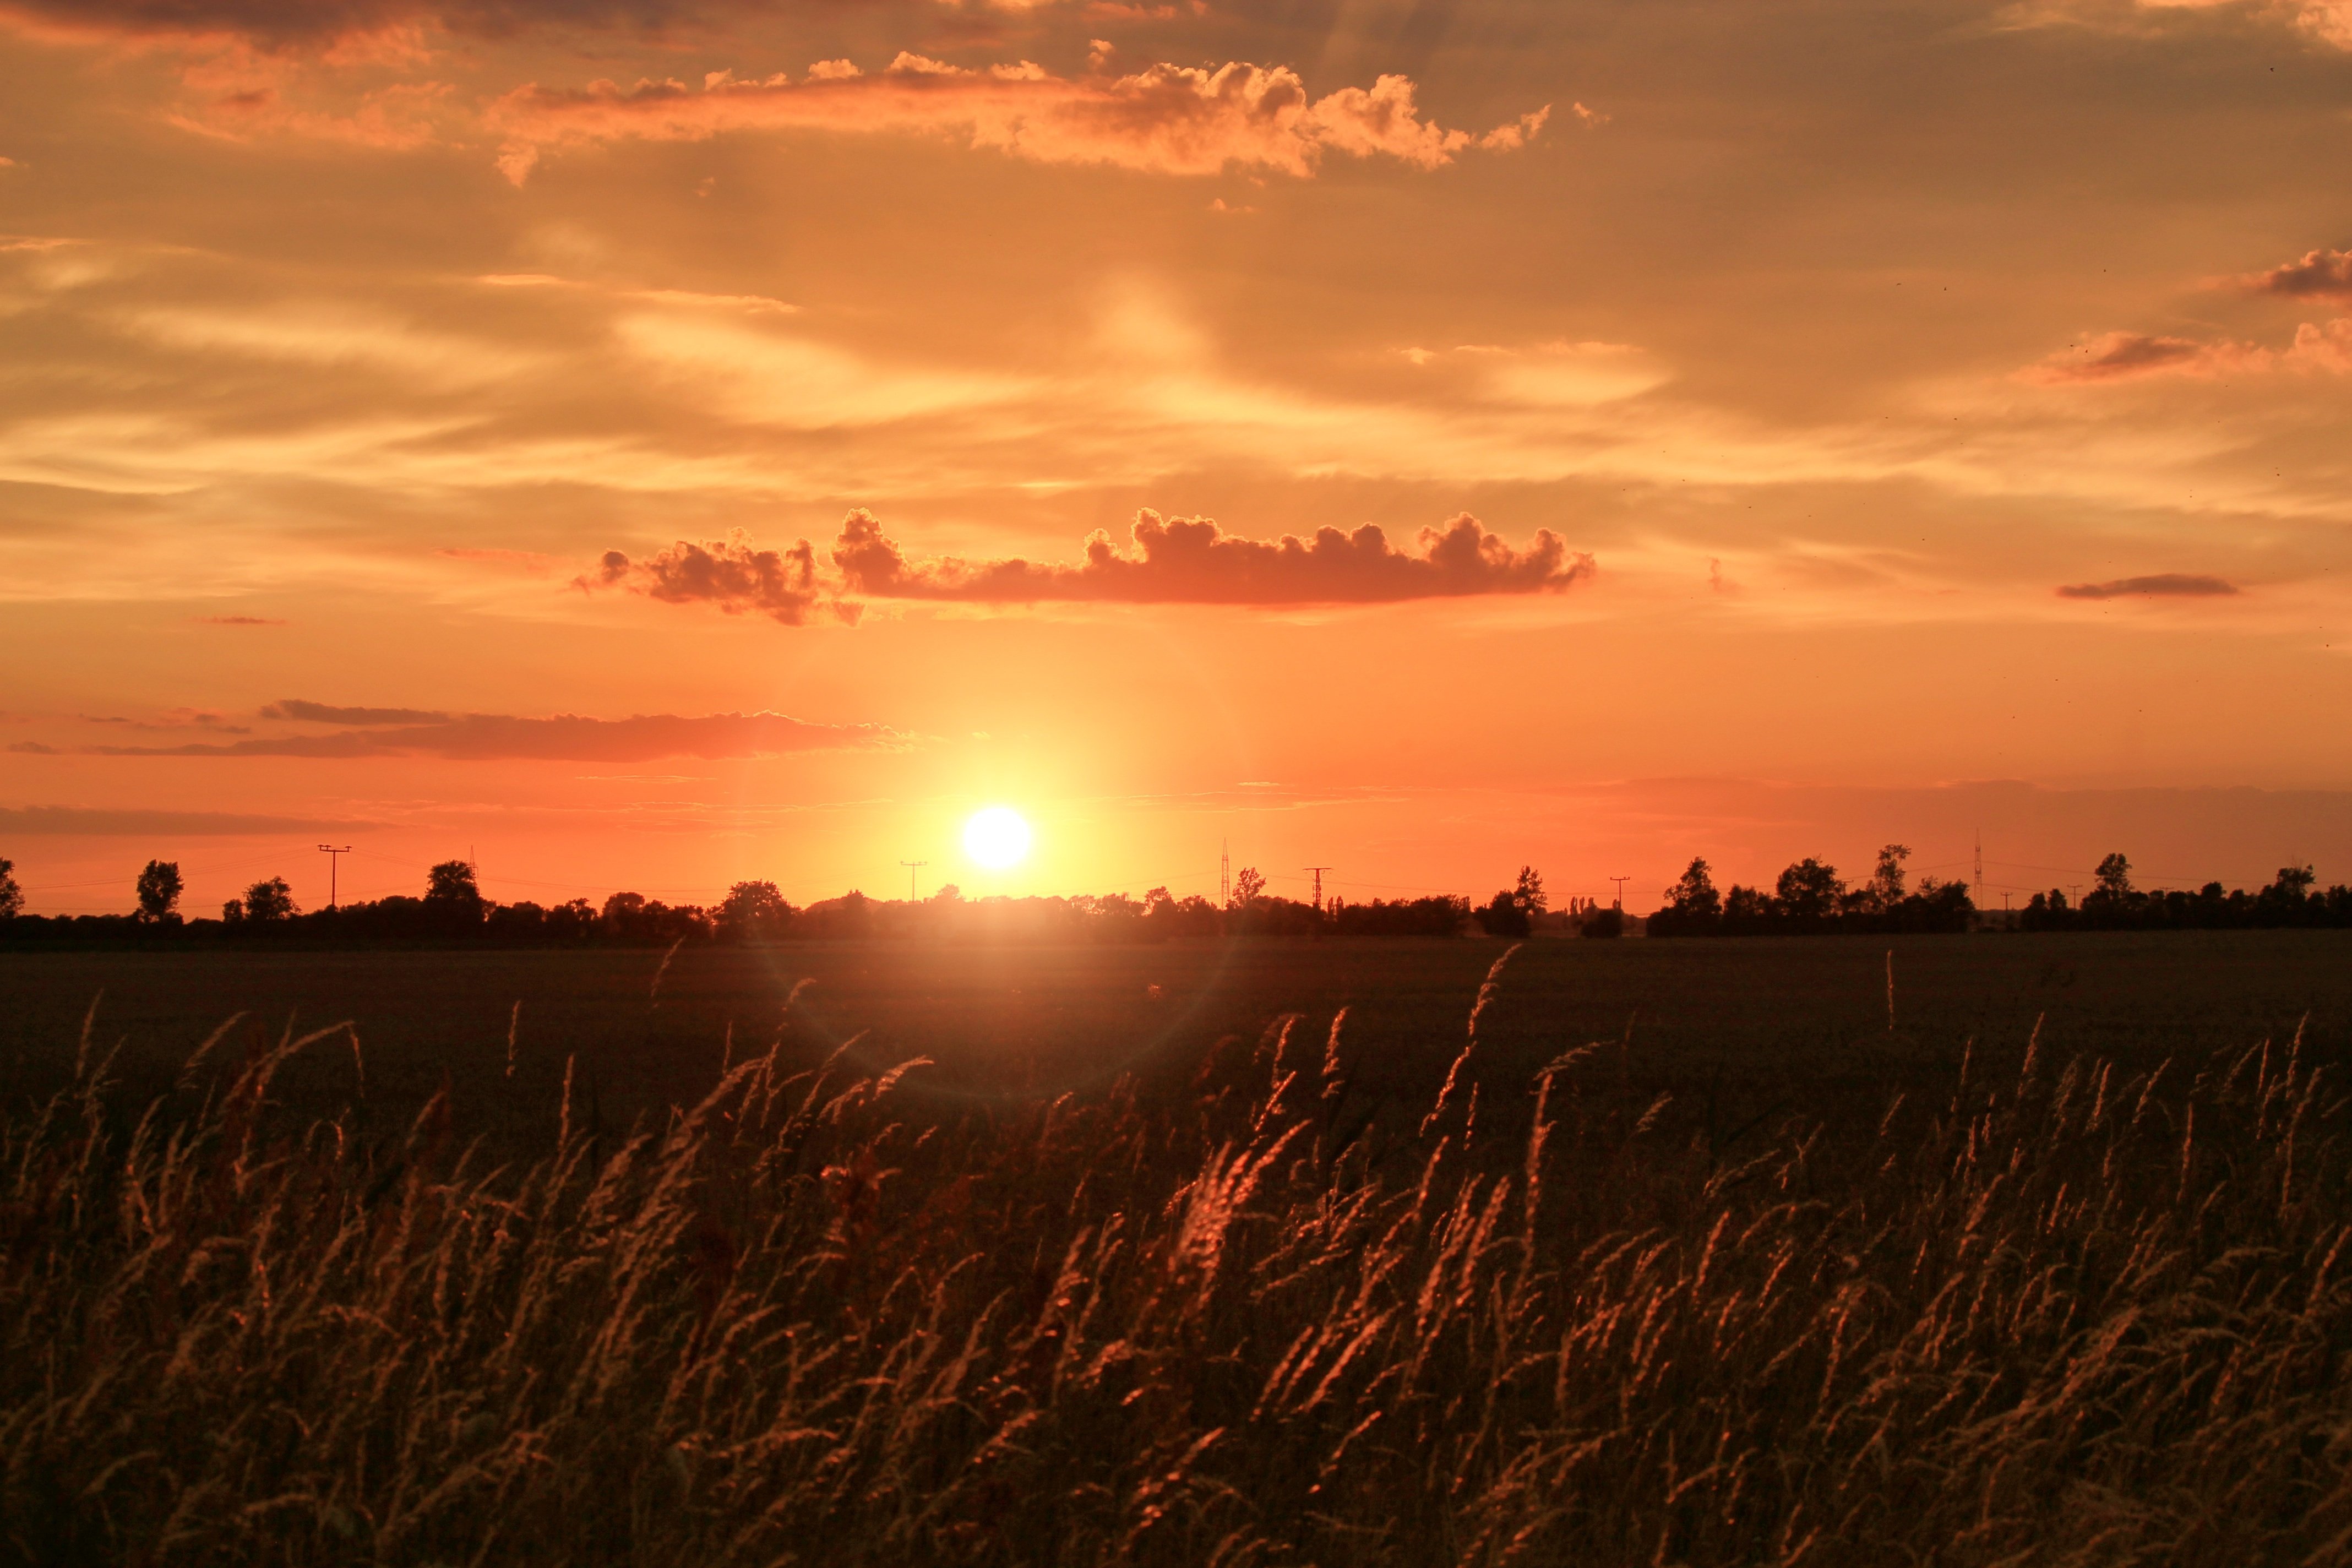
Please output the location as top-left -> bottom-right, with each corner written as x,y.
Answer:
80,703 -> 910,761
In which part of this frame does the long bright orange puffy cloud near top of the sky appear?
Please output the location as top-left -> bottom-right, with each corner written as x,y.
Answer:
489,54 -> 1550,183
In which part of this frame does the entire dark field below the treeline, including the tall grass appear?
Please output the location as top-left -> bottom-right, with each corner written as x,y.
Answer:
0,933 -> 2352,1563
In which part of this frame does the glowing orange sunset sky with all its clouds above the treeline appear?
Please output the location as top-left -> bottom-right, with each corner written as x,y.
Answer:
0,0 -> 2352,912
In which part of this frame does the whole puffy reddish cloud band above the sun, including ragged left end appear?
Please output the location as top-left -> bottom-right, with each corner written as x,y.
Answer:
592,508 -> 1594,625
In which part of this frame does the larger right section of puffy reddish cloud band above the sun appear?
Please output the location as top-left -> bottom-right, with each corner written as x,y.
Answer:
832,510 -> 1592,604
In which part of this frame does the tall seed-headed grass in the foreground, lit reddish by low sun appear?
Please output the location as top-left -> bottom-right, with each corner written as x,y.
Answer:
0,982 -> 2352,1566
